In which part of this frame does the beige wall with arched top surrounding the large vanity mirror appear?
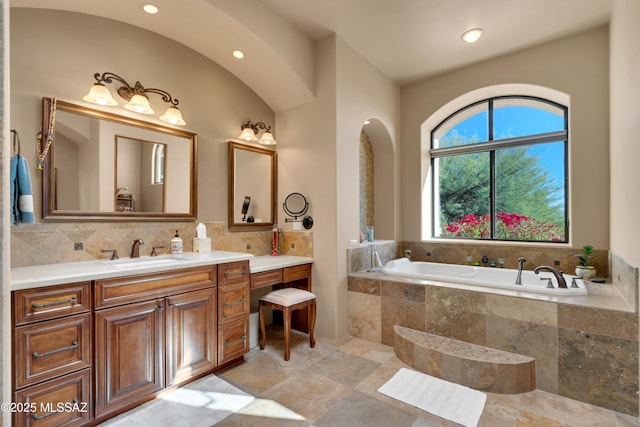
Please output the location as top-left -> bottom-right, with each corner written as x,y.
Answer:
11,8 -> 277,224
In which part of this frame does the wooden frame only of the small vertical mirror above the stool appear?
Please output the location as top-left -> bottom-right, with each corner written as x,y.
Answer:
227,141 -> 278,231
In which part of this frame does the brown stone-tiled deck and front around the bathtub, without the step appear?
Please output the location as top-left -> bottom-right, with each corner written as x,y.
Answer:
348,272 -> 639,416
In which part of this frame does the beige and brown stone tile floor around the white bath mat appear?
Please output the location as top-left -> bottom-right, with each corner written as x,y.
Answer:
97,328 -> 640,427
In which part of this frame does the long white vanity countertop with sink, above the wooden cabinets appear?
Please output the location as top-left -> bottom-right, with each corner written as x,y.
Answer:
11,251 -> 313,291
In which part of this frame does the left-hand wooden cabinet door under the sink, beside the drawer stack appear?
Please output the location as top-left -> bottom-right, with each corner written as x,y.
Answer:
95,299 -> 165,417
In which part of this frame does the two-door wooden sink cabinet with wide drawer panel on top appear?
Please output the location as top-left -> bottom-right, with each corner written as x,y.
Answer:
95,266 -> 216,418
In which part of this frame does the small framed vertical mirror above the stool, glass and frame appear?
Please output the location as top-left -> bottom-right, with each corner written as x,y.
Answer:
228,141 -> 277,231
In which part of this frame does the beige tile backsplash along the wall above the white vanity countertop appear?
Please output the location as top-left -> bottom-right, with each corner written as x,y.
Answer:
11,221 -> 313,267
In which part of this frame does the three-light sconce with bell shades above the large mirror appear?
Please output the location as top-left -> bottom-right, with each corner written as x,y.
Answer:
82,72 -> 186,126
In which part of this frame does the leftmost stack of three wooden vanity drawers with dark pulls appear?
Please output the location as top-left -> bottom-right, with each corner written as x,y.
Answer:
12,282 -> 93,426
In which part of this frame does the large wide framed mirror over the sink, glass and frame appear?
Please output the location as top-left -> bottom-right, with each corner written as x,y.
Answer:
42,98 -> 198,221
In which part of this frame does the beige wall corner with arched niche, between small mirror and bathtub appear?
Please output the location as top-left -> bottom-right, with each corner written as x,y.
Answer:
276,35 -> 400,338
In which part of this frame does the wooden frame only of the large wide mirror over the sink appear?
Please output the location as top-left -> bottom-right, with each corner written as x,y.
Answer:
42,98 -> 198,222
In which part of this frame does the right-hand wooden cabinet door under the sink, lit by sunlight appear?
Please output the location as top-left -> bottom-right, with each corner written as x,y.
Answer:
167,288 -> 216,387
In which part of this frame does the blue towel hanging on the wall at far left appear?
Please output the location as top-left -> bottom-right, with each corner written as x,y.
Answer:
9,154 -> 34,224
